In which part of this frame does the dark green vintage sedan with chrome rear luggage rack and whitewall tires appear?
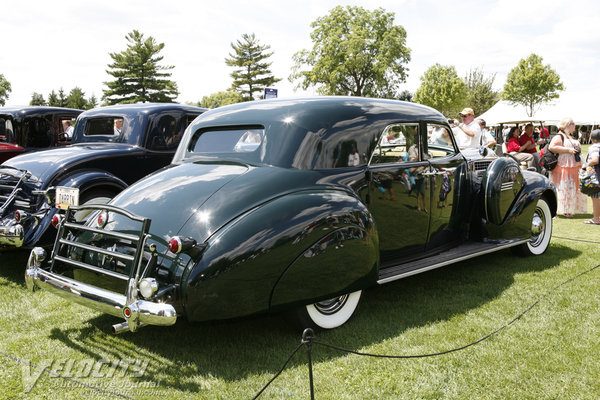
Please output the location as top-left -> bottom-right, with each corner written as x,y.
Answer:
26,97 -> 556,332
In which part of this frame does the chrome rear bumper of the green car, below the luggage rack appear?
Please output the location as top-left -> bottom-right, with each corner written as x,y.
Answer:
25,247 -> 177,333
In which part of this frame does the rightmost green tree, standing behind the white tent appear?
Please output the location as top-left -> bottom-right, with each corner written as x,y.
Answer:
502,54 -> 565,117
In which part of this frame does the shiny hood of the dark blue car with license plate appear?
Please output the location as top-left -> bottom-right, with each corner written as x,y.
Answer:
2,143 -> 142,185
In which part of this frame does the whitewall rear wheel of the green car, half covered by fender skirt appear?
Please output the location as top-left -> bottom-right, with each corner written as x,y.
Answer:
296,290 -> 362,329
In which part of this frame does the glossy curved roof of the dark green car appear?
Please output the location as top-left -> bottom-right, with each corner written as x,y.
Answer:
175,97 -> 447,169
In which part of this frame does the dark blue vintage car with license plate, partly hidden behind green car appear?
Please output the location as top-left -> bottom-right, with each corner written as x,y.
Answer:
0,104 -> 204,248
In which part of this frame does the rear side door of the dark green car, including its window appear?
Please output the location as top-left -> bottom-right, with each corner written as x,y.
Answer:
368,123 -> 431,266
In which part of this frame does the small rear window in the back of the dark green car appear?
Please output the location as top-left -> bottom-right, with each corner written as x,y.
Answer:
188,127 -> 265,154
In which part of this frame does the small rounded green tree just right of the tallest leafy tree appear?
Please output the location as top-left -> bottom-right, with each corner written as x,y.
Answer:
413,64 -> 467,116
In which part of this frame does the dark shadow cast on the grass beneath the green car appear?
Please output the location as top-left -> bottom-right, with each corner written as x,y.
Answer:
37,244 -> 580,392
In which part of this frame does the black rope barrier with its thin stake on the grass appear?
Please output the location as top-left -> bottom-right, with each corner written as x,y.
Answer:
252,264 -> 600,400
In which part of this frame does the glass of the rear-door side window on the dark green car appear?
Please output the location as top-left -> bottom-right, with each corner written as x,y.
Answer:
370,123 -> 426,164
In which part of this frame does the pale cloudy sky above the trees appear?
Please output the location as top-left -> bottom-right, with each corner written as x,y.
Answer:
0,0 -> 600,113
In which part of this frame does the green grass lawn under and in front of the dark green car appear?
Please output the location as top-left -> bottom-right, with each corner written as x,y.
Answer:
0,198 -> 600,399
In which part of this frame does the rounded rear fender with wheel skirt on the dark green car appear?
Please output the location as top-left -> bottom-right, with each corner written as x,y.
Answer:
182,190 -> 378,320
